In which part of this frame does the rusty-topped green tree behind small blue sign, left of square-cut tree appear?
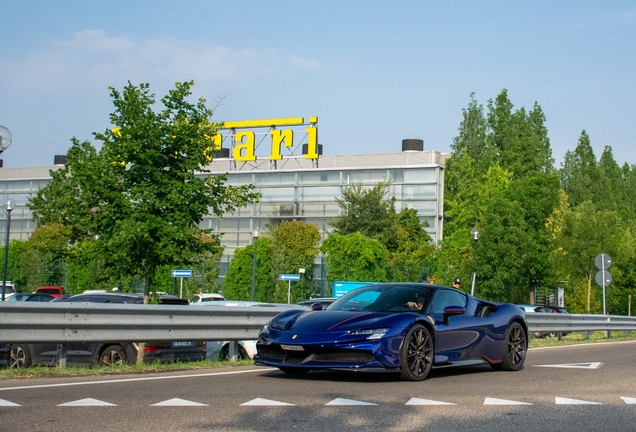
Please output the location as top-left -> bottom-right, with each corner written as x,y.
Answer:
271,221 -> 320,303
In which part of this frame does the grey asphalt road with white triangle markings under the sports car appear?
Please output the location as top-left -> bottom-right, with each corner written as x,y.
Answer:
0,342 -> 636,432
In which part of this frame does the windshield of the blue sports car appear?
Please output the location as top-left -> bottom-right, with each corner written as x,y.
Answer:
327,285 -> 430,312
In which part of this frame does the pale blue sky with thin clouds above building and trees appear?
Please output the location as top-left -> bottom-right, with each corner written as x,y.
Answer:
0,0 -> 636,167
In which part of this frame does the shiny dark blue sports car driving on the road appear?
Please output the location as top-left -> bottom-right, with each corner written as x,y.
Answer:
254,283 -> 528,381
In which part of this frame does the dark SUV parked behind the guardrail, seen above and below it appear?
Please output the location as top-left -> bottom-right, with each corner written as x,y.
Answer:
8,293 -> 205,367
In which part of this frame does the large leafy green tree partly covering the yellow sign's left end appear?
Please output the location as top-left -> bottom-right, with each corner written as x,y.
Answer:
29,82 -> 258,302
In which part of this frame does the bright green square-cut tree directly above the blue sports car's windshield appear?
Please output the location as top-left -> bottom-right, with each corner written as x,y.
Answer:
321,232 -> 389,283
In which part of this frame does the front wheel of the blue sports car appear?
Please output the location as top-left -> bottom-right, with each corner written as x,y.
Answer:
400,324 -> 433,381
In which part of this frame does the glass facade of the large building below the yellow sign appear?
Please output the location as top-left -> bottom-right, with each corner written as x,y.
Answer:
0,153 -> 444,280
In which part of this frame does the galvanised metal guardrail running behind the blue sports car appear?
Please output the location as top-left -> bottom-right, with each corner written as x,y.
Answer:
0,302 -> 636,344
